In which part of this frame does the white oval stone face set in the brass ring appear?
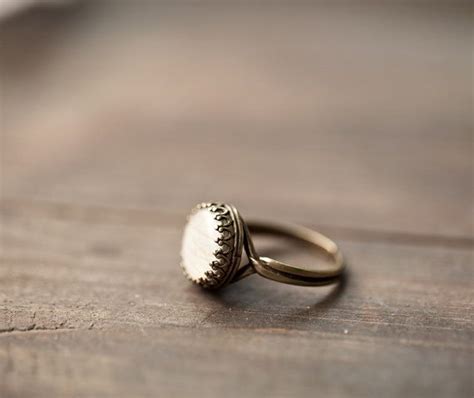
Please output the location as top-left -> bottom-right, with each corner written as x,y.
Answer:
181,208 -> 220,281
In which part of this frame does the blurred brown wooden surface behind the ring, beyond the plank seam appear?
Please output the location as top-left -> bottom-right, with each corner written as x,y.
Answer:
0,1 -> 472,237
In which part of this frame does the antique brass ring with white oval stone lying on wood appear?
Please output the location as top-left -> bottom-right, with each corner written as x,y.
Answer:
181,203 -> 344,289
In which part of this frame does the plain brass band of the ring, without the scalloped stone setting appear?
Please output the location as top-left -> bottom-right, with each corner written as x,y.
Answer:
245,221 -> 344,286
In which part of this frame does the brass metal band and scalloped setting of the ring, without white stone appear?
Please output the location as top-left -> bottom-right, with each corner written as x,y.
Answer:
181,203 -> 344,289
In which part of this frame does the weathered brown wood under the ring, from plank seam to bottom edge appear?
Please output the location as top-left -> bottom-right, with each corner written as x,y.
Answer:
0,204 -> 473,397
